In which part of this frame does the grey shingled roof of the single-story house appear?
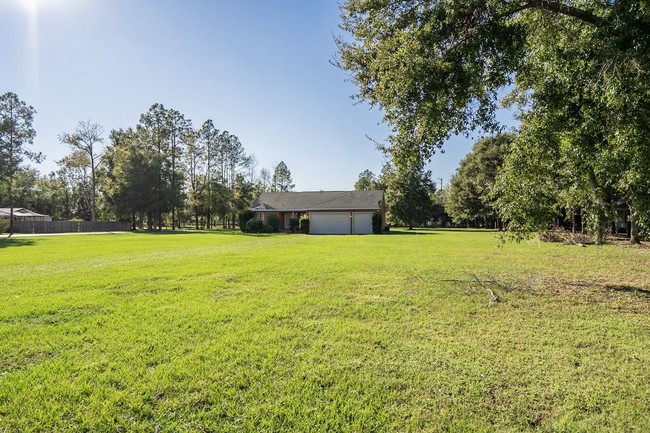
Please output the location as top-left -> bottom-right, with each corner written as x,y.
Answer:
251,191 -> 384,212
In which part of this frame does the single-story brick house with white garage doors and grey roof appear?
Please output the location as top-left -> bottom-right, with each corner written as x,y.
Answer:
251,191 -> 385,234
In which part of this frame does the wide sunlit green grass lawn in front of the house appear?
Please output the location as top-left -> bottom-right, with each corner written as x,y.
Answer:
0,231 -> 650,433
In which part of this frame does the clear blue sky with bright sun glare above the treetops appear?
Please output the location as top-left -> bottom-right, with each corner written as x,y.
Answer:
0,0 -> 516,190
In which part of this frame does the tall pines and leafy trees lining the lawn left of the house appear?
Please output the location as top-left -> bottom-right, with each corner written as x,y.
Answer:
0,93 -> 294,230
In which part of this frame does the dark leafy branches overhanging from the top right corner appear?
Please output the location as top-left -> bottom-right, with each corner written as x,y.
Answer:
337,0 -> 650,160
